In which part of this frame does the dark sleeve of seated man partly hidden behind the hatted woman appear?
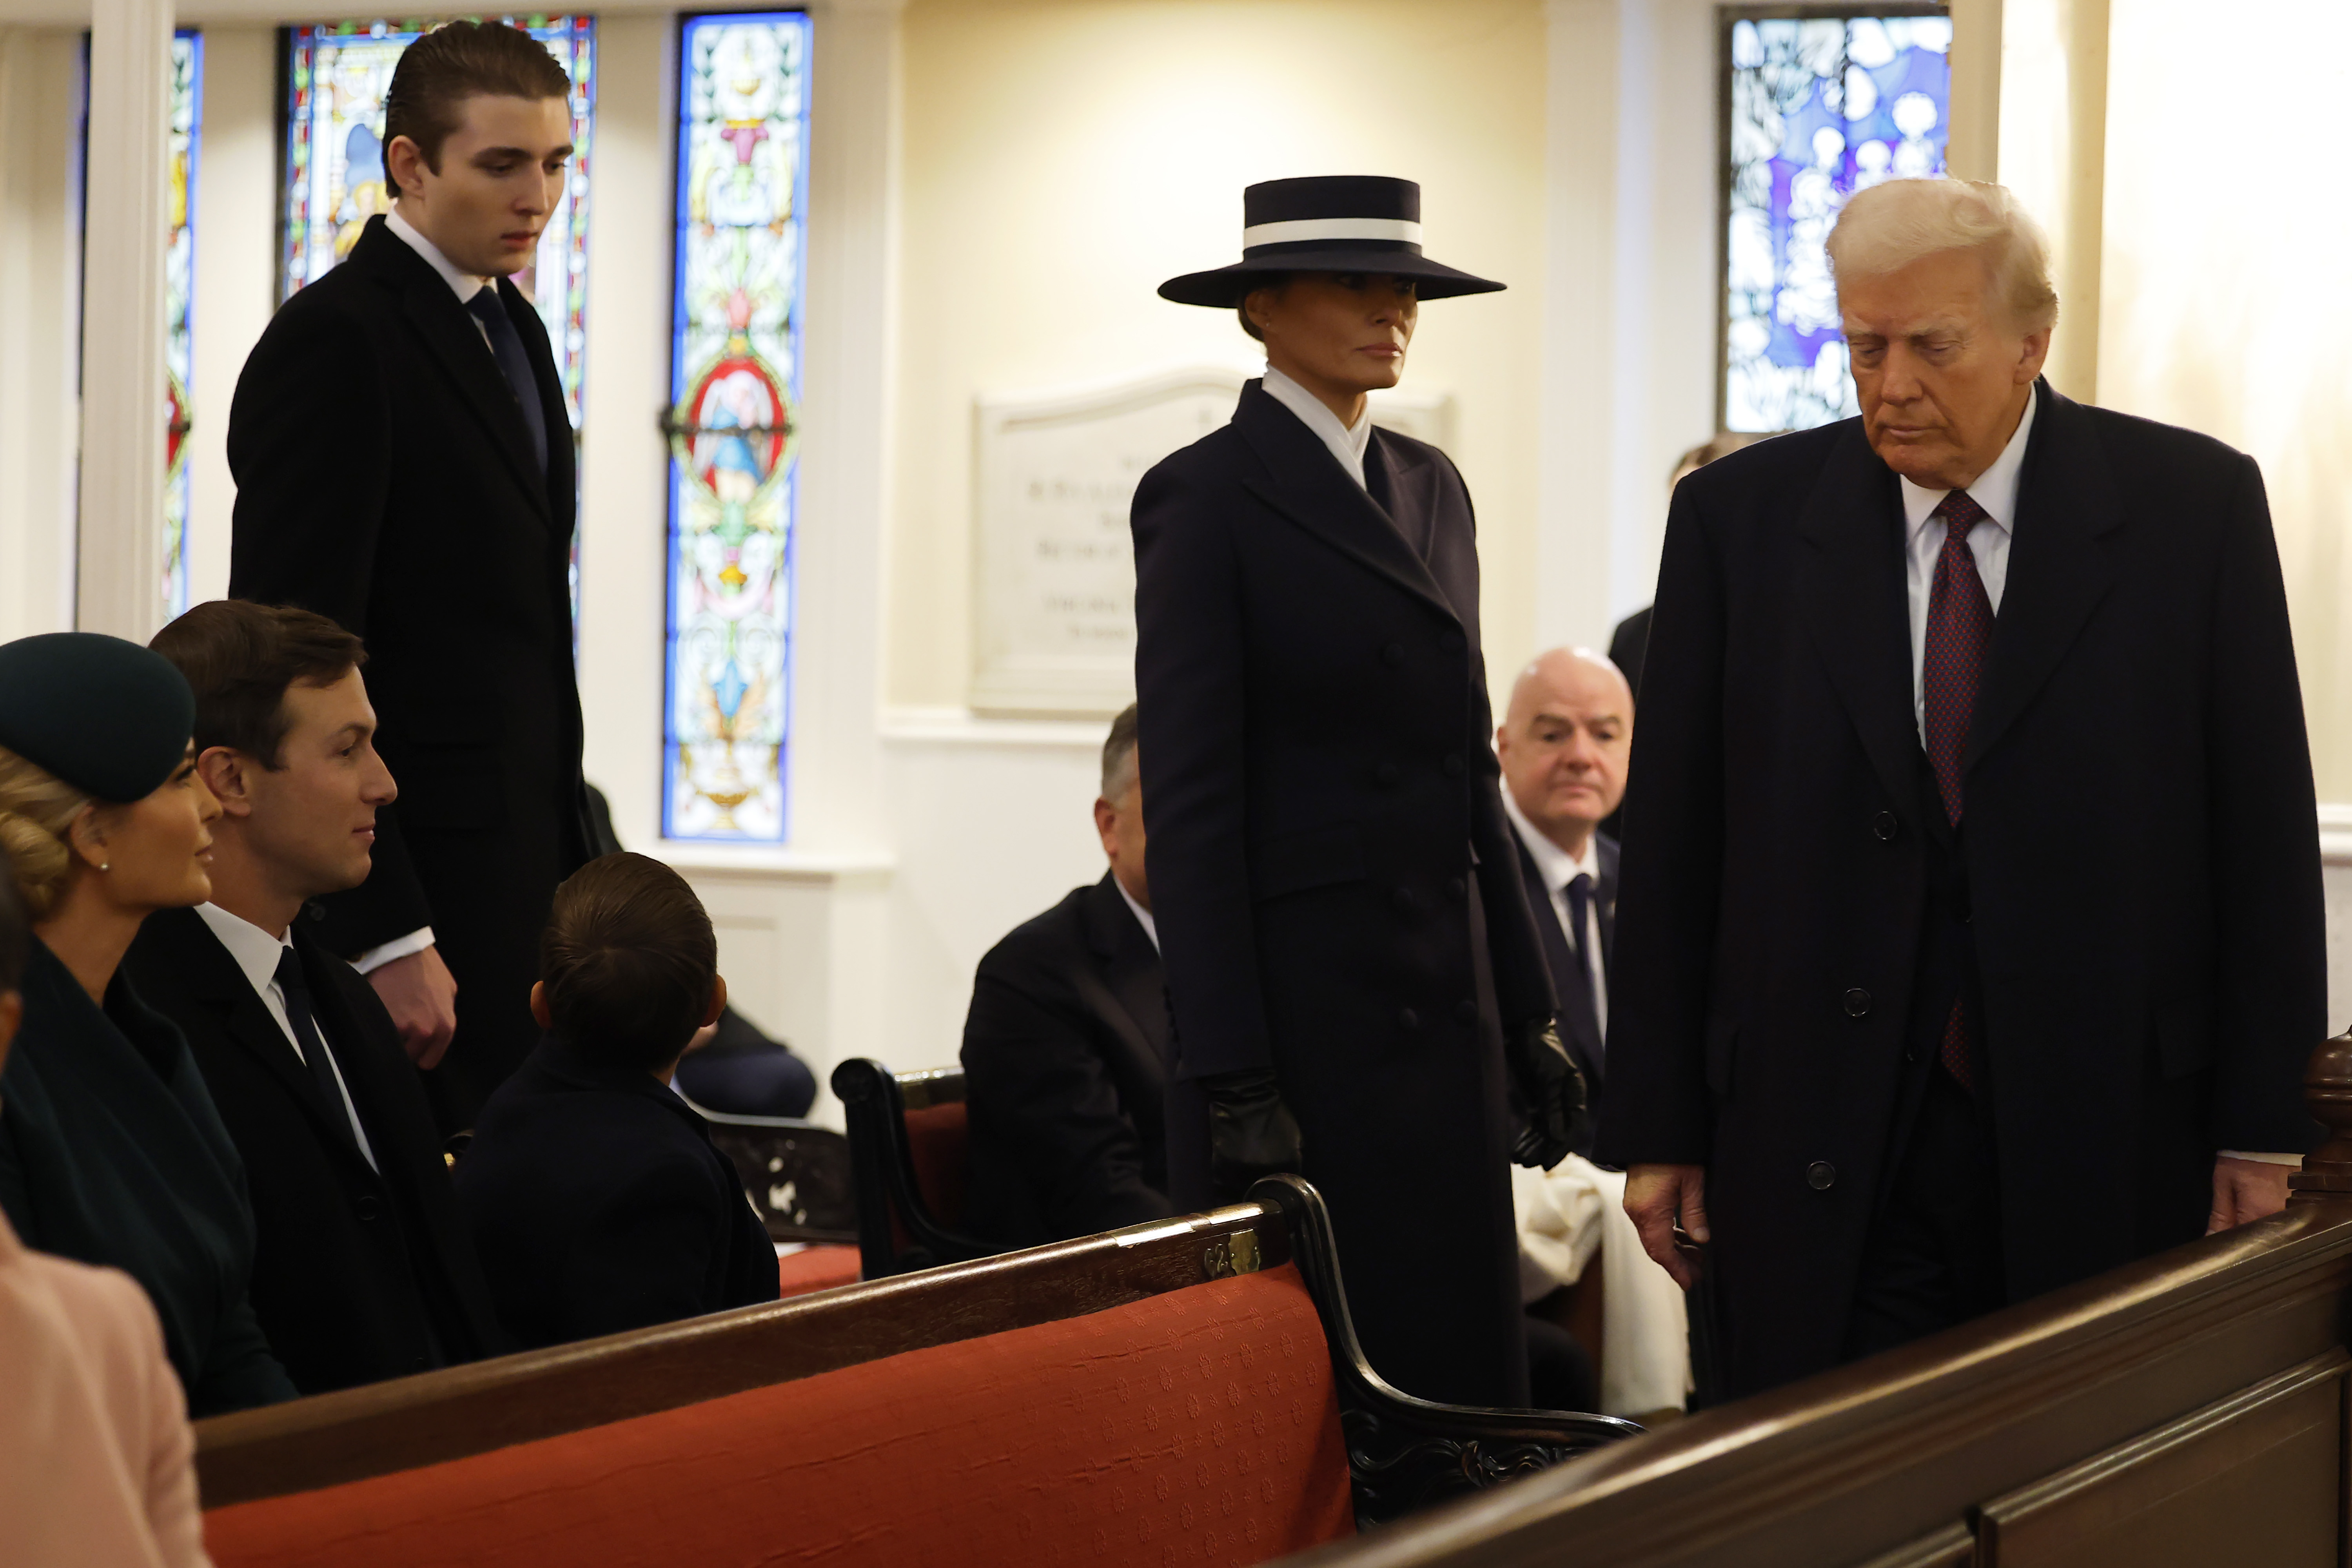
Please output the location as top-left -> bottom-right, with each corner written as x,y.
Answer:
964,961 -> 1174,1239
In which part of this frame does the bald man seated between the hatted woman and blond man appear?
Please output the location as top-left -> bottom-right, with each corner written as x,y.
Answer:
1494,649 -> 1632,1157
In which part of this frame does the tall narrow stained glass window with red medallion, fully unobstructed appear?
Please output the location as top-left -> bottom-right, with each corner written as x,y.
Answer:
661,12 -> 809,841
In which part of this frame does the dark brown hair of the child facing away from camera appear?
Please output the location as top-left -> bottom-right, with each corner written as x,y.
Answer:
539,851 -> 720,1072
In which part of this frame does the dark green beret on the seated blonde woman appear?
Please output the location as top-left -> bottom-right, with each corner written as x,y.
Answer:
0,633 -> 195,804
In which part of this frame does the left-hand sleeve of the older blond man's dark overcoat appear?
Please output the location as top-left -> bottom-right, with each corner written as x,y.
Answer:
1595,484 -> 1724,1166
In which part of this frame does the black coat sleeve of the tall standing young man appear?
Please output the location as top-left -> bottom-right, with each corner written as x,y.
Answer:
228,294 -> 433,957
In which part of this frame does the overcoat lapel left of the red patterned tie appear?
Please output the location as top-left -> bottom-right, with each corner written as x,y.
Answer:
1797,419 -> 1950,832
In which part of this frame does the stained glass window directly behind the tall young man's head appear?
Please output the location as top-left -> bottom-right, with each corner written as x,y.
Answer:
278,16 -> 595,430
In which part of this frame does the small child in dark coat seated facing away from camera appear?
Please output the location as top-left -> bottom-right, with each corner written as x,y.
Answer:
456,853 -> 776,1347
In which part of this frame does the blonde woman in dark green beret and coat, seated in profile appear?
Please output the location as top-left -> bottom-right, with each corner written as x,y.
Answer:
0,633 -> 294,1415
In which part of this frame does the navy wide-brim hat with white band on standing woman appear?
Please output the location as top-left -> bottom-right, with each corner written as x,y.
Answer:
1160,174 -> 1503,310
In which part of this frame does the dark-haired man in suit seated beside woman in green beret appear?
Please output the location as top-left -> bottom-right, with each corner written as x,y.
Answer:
122,600 -> 506,1394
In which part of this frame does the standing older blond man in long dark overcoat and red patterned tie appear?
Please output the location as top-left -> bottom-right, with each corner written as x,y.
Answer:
1599,181 -> 2324,1394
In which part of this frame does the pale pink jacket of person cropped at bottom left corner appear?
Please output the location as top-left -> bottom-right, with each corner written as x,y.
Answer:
0,1215 -> 209,1568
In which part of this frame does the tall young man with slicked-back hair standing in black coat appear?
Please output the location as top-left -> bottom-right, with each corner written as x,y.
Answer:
228,21 -> 588,1131
